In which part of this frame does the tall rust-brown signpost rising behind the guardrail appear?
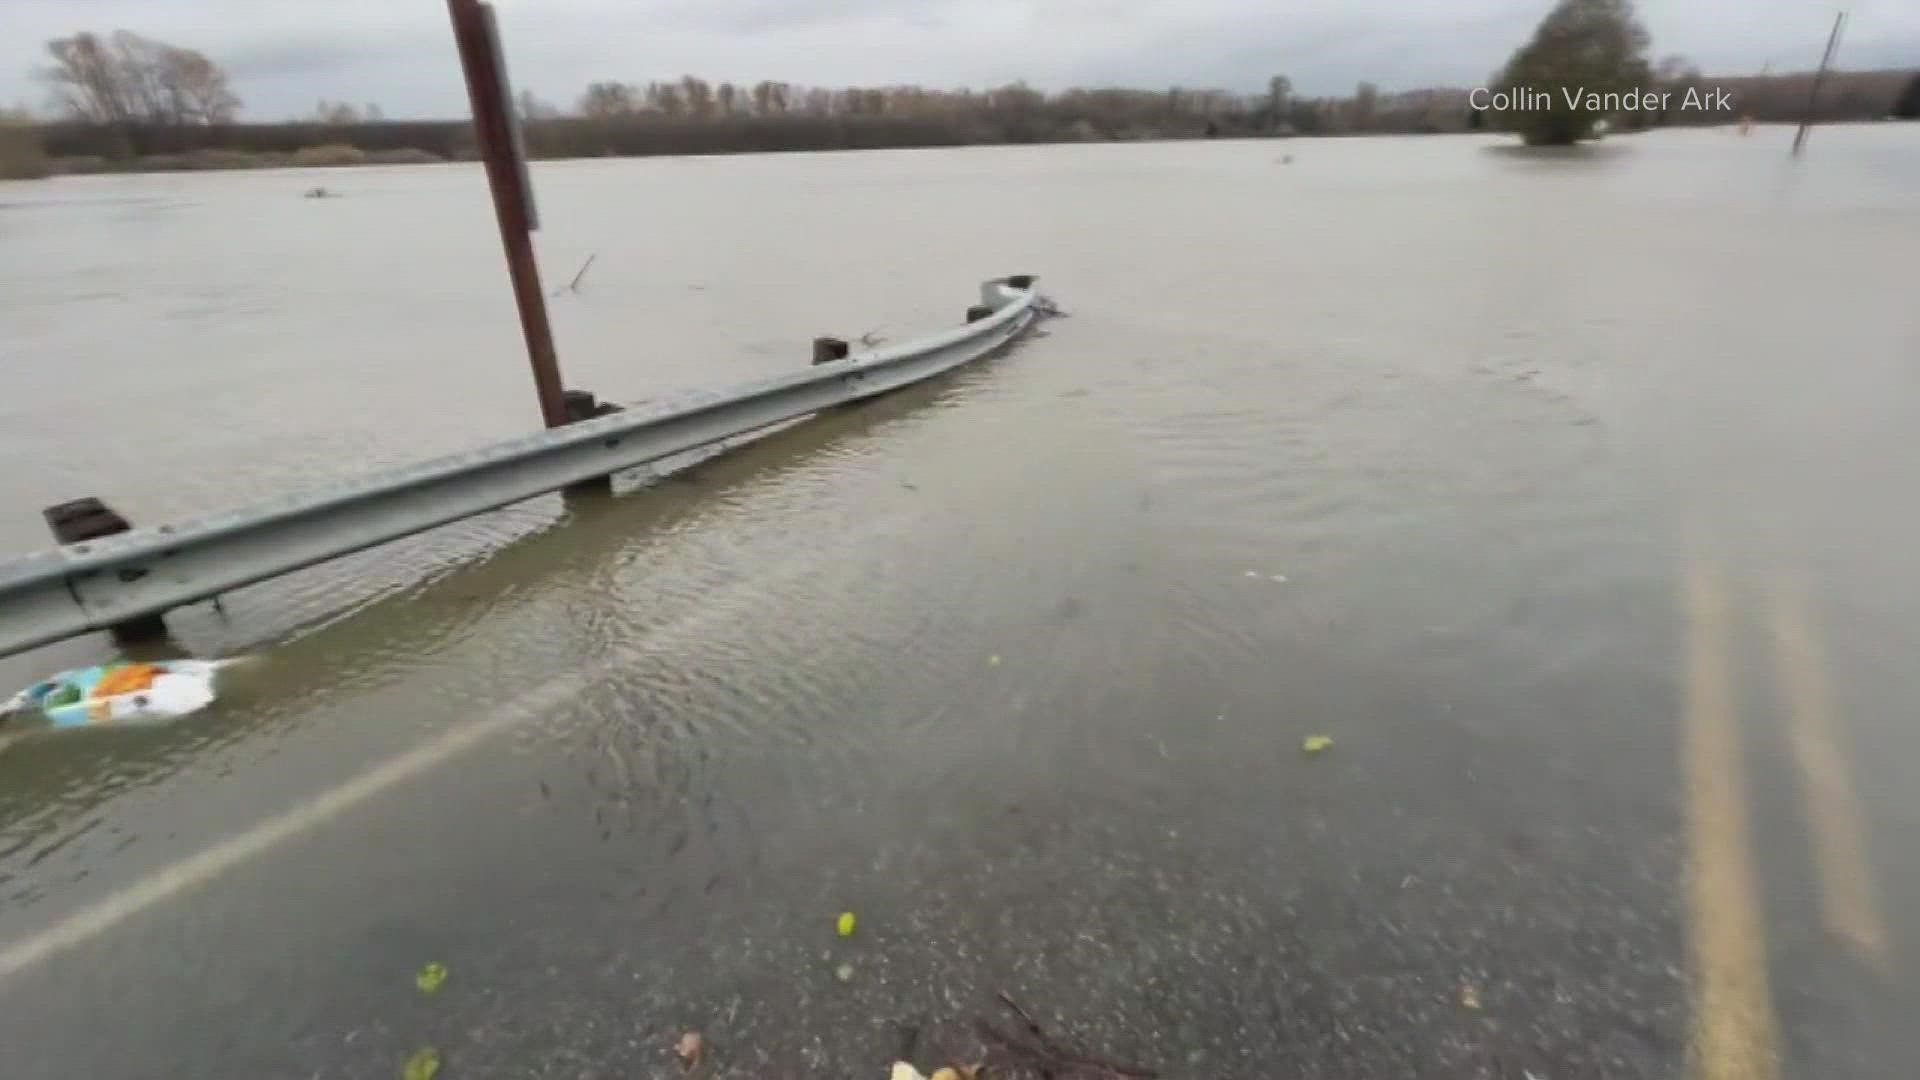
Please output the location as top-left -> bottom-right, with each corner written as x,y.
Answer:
447,0 -> 568,427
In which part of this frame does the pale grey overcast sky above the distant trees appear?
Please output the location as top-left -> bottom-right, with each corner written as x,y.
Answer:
0,0 -> 1920,119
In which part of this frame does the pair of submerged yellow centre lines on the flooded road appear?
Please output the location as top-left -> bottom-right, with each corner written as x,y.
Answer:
1684,544 -> 1887,1080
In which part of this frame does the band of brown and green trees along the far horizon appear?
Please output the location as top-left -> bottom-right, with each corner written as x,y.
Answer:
0,0 -> 1920,177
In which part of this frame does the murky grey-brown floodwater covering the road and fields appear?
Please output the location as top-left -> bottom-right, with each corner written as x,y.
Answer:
0,125 -> 1920,1080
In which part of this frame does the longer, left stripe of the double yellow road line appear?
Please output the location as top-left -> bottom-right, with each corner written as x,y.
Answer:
1686,559 -> 1780,1080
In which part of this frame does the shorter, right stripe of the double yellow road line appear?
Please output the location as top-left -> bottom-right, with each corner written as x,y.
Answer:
1766,578 -> 1889,972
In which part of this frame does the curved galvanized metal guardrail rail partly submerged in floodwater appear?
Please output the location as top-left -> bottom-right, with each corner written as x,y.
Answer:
0,277 -> 1039,657
